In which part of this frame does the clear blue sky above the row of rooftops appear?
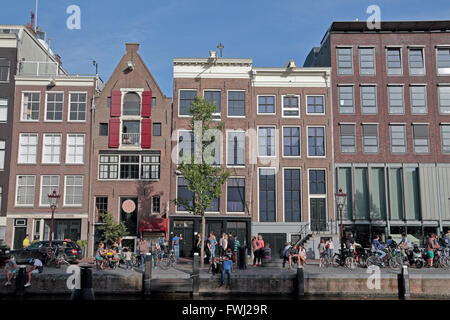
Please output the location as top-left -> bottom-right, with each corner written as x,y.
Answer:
0,0 -> 450,96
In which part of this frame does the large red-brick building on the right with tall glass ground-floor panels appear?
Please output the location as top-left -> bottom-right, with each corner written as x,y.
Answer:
304,21 -> 450,243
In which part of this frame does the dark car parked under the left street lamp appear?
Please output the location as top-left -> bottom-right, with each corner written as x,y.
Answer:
11,240 -> 82,264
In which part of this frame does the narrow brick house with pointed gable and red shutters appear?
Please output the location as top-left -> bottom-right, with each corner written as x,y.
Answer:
89,43 -> 172,254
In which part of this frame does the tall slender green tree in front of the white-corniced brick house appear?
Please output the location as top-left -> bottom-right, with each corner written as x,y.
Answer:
174,97 -> 230,267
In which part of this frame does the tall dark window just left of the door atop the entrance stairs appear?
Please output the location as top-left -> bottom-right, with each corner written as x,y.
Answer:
283,169 -> 302,222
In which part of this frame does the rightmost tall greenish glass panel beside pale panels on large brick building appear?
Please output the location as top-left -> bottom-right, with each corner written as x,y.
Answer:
404,168 -> 420,220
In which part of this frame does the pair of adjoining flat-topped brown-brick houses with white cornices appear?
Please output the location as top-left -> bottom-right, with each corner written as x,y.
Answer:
169,52 -> 335,256
